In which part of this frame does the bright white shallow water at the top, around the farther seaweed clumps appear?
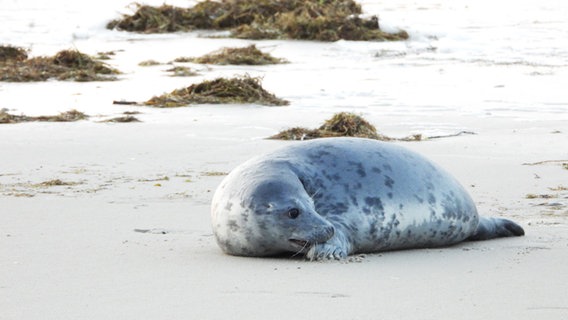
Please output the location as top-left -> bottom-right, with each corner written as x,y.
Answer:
0,0 -> 568,127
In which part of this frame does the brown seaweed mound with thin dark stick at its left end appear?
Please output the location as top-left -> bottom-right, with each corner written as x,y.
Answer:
144,76 -> 289,108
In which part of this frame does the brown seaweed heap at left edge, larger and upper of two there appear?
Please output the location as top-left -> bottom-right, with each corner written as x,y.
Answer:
0,47 -> 120,82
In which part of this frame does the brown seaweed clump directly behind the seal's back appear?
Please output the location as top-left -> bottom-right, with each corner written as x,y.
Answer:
269,112 -> 392,141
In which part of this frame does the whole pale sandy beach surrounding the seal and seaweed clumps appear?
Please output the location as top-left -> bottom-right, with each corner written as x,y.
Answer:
0,1 -> 568,320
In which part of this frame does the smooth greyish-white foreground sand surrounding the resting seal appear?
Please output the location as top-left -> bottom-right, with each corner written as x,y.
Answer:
0,107 -> 568,319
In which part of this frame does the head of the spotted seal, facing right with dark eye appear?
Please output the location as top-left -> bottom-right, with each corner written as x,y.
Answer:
211,165 -> 334,256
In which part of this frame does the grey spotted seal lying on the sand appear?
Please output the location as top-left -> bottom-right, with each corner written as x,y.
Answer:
211,138 -> 524,260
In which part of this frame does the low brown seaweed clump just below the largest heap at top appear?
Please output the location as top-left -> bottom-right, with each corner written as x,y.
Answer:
182,44 -> 286,65
